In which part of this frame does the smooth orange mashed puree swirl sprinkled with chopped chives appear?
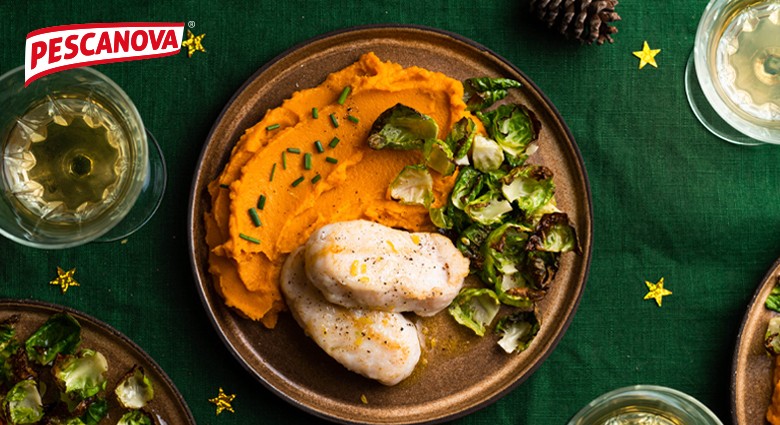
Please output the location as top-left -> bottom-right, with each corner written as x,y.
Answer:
205,53 -> 478,328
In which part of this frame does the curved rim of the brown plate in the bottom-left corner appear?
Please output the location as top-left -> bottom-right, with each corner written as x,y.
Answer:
0,297 -> 197,425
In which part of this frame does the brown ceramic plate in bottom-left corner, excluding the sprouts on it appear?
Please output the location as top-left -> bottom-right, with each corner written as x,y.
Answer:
0,299 -> 195,425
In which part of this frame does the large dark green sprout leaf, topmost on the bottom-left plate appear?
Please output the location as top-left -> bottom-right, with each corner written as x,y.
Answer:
25,313 -> 81,365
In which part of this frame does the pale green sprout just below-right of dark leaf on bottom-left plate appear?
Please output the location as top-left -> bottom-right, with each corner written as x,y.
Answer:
52,349 -> 108,400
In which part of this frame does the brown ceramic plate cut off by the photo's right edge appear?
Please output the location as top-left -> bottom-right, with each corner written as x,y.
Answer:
731,260 -> 780,425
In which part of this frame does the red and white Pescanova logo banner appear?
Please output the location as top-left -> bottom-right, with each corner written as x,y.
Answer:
24,22 -> 184,86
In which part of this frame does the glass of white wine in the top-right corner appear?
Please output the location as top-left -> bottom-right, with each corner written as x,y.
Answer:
685,0 -> 780,145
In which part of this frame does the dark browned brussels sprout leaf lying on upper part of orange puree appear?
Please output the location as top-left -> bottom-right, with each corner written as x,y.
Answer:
368,103 -> 439,150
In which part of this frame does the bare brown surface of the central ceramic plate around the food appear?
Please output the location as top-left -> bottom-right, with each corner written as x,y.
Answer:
189,26 -> 592,424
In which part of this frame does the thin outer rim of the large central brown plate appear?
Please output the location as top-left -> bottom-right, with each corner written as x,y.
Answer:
187,23 -> 594,424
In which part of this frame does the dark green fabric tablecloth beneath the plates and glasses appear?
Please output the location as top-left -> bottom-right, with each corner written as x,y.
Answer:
0,0 -> 780,424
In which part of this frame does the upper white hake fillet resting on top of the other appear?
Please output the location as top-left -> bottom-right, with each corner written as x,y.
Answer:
305,220 -> 469,316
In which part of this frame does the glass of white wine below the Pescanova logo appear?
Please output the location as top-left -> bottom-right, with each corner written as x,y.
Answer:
0,67 -> 166,249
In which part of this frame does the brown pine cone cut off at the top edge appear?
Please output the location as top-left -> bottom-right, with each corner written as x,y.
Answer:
531,0 -> 620,45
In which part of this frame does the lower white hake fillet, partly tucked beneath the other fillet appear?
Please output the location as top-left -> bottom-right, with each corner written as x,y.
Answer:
281,248 -> 420,385
